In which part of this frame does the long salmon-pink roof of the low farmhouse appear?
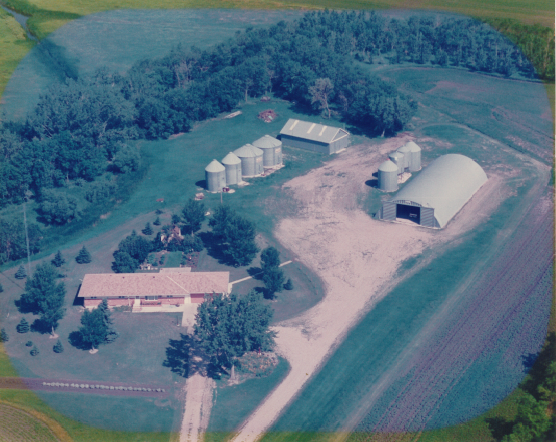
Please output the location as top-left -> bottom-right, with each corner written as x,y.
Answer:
78,272 -> 230,298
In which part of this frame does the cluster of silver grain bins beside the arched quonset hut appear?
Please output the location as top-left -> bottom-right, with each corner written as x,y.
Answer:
378,141 -> 421,192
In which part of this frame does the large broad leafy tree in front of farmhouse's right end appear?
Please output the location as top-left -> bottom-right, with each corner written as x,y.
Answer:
194,291 -> 275,378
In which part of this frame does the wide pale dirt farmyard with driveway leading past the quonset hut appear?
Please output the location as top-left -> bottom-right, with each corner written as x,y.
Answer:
228,136 -> 524,442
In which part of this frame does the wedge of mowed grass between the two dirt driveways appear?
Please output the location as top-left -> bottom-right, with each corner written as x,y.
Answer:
205,358 -> 289,442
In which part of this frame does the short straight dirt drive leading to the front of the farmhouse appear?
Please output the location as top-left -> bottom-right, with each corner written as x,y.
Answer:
180,373 -> 215,442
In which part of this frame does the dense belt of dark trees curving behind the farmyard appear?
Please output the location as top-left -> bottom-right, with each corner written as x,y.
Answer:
0,11 -> 544,261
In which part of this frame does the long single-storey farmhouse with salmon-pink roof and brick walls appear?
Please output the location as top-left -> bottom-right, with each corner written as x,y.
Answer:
77,269 -> 230,308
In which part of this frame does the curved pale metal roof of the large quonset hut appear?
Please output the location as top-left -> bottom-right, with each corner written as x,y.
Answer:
390,154 -> 488,228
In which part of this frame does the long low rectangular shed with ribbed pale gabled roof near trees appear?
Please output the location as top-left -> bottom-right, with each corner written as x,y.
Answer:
280,118 -> 349,154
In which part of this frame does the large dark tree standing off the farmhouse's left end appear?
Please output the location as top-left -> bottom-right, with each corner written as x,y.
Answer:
21,263 -> 66,333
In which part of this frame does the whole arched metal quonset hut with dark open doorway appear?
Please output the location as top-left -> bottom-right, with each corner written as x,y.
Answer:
379,154 -> 487,229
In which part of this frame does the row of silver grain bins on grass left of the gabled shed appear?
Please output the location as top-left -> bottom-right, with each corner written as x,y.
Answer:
205,135 -> 282,192
